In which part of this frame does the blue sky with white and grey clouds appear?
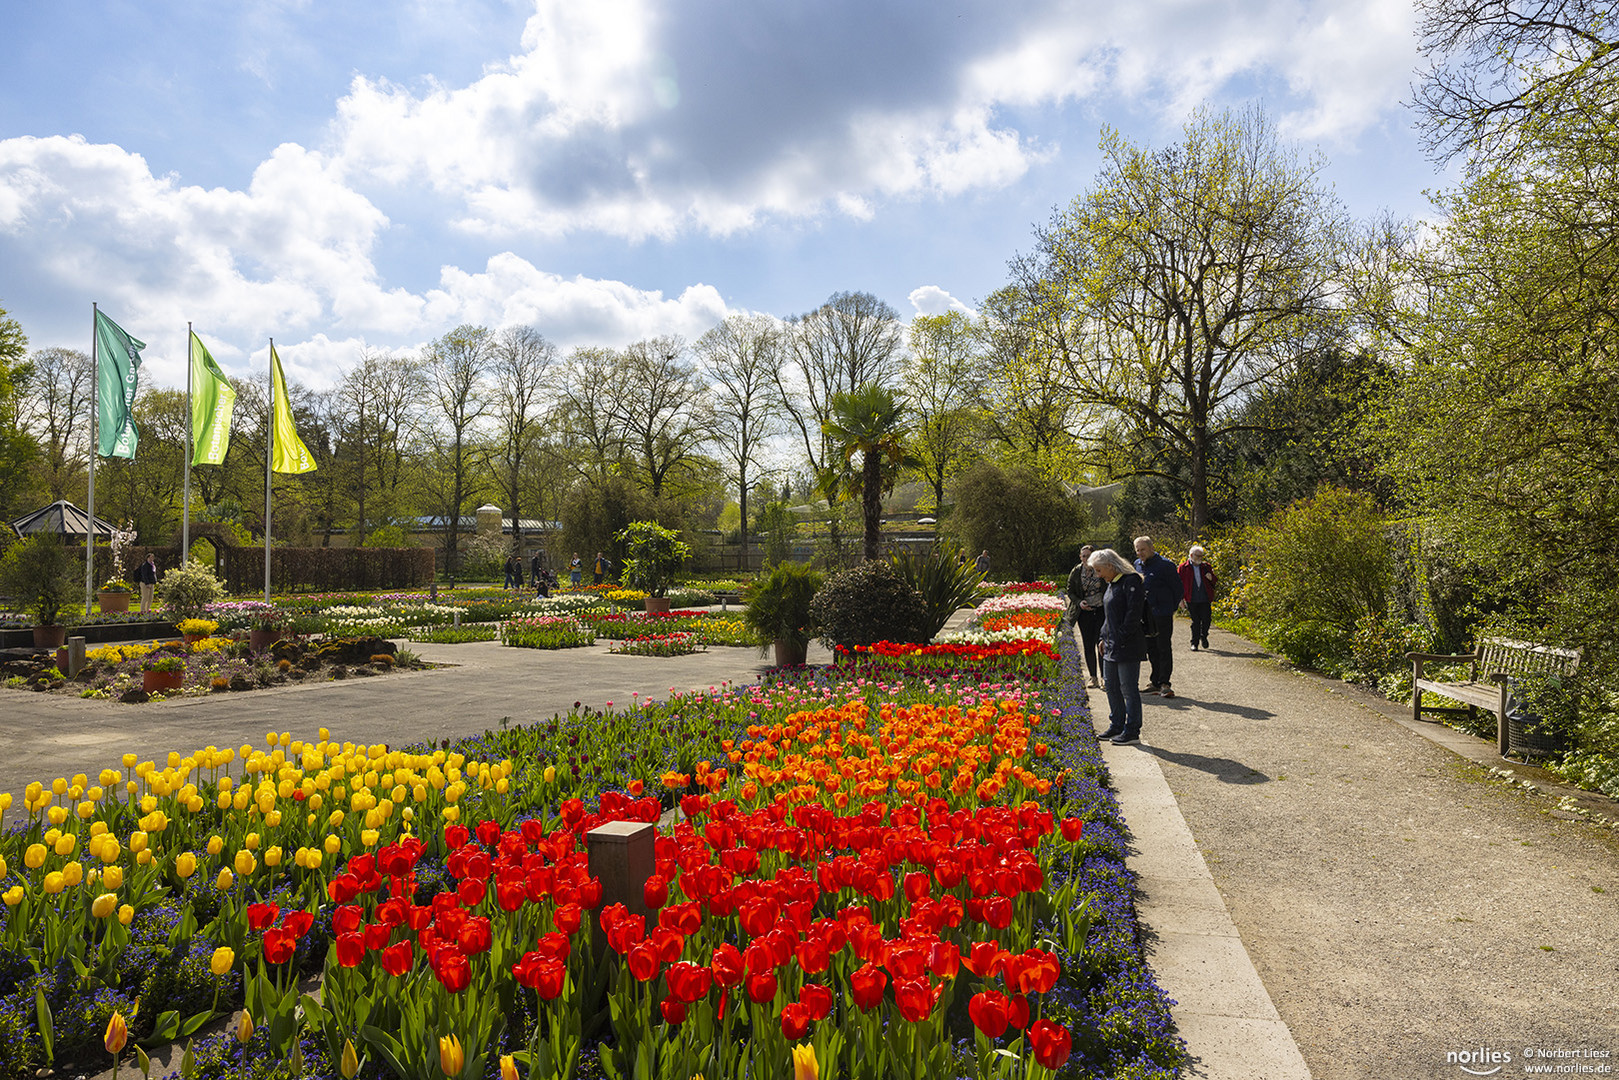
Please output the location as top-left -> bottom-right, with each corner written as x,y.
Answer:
0,0 -> 1446,389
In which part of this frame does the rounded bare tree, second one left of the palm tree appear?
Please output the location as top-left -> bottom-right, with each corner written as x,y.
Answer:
612,337 -> 709,499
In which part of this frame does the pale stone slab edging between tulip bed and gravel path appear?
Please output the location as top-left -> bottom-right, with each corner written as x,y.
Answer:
1103,743 -> 1311,1080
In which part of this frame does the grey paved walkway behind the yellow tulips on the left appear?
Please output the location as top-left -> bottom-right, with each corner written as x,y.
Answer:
0,641 -> 831,806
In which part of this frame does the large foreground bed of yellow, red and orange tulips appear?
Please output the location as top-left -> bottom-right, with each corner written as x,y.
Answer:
0,643 -> 1183,1080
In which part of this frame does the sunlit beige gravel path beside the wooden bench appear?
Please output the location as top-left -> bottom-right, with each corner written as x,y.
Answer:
1139,623 -> 1619,1080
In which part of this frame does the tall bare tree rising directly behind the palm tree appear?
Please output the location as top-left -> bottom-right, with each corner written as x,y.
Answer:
776,293 -> 903,474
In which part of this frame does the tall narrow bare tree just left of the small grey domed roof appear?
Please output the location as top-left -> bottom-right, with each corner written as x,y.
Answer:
424,325 -> 494,578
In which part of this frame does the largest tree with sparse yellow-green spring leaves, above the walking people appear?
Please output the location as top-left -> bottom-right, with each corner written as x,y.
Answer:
1015,103 -> 1347,534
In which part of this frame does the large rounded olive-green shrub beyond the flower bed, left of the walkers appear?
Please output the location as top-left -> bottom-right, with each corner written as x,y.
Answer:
950,463 -> 1085,581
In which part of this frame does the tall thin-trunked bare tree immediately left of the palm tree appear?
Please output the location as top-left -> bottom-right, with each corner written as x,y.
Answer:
696,316 -> 782,550
